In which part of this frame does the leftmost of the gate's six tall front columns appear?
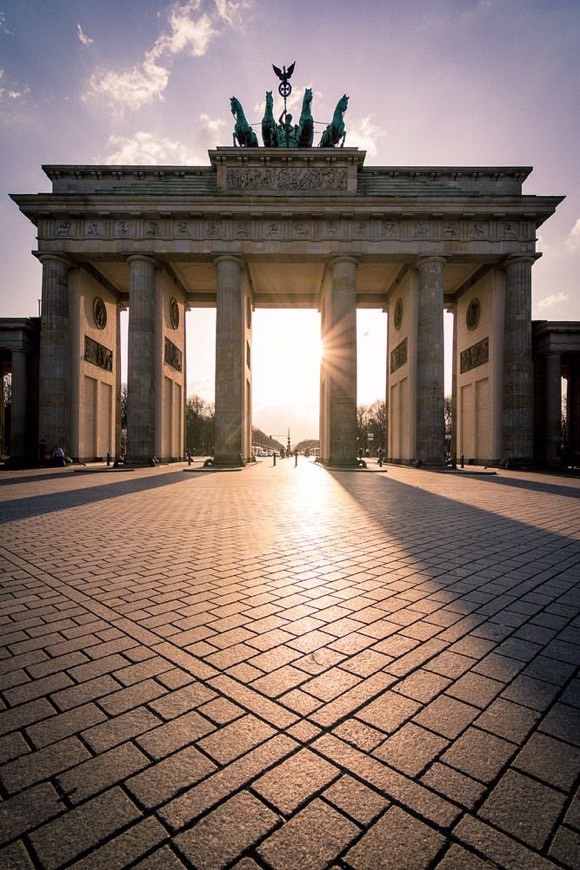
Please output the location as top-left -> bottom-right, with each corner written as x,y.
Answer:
38,254 -> 71,453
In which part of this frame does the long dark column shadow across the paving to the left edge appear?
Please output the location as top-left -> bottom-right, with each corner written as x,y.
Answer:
0,470 -> 201,525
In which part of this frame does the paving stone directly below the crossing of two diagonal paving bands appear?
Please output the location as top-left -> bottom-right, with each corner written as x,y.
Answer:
252,749 -> 340,815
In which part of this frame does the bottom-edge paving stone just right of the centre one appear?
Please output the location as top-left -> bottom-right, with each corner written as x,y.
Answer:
346,807 -> 445,870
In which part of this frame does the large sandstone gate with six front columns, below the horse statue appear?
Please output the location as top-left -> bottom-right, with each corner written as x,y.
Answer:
13,85 -> 562,466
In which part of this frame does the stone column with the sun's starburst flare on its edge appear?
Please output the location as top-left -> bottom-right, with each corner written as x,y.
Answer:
324,257 -> 357,465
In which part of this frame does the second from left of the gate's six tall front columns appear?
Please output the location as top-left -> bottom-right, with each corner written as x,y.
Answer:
127,255 -> 156,464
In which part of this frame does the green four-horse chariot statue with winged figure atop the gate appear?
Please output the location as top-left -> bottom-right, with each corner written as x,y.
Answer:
230,63 -> 348,148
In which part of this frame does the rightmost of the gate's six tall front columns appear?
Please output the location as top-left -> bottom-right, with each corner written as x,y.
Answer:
503,257 -> 534,463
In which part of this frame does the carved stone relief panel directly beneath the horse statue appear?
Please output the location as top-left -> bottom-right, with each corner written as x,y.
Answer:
226,166 -> 347,193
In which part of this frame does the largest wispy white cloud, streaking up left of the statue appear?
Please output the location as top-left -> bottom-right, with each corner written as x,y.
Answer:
79,0 -> 253,111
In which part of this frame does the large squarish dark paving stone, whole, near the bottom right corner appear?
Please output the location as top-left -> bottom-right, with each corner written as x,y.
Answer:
479,770 -> 564,850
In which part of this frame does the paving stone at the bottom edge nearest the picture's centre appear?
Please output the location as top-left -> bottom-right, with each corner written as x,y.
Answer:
258,799 -> 359,870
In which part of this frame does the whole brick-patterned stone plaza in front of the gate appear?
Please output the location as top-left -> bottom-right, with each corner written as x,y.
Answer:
0,457 -> 580,870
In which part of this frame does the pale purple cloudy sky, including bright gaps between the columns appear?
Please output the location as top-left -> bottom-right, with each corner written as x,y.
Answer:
0,0 -> 580,440
